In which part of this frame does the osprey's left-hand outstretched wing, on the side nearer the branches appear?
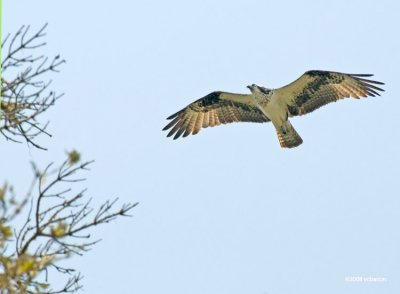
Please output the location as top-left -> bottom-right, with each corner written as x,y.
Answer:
163,91 -> 269,139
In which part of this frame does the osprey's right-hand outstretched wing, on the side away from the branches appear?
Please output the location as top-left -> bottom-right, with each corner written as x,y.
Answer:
275,70 -> 384,116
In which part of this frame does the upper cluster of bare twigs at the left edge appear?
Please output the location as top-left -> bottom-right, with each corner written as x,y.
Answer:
0,24 -> 65,150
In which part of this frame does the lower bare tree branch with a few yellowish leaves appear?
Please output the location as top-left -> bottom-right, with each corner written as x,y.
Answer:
0,152 -> 138,294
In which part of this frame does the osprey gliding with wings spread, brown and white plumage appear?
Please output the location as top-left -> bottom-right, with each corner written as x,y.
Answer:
163,70 -> 384,148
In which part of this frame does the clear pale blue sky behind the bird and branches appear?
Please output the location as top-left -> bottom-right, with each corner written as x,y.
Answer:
0,0 -> 400,294
